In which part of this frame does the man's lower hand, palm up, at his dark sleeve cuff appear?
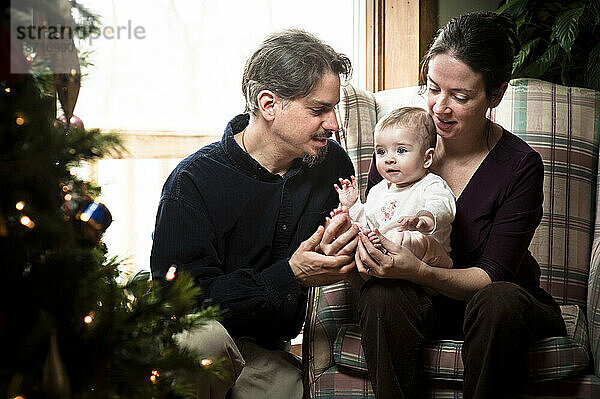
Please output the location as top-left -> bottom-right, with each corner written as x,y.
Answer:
290,226 -> 357,287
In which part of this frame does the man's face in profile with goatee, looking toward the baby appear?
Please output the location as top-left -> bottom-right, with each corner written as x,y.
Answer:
273,73 -> 340,165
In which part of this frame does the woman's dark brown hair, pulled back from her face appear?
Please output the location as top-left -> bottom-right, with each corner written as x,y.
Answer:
419,12 -> 521,99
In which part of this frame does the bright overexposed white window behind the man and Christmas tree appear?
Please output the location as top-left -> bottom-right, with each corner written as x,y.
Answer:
75,0 -> 366,276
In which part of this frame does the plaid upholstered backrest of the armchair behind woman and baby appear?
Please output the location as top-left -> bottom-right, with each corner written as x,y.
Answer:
341,79 -> 600,307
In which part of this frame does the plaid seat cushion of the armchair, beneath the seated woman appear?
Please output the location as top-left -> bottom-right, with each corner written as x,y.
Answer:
334,305 -> 590,382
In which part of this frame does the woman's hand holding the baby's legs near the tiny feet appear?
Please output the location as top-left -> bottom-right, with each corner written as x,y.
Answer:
355,230 -> 424,281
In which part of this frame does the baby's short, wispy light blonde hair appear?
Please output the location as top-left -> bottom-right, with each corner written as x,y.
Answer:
375,107 -> 437,149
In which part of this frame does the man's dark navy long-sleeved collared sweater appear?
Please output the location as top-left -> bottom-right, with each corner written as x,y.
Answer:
150,115 -> 354,347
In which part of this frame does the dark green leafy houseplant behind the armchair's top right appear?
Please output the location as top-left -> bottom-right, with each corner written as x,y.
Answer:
496,0 -> 600,90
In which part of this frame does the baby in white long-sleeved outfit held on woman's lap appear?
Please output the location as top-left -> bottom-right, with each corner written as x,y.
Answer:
331,107 -> 456,276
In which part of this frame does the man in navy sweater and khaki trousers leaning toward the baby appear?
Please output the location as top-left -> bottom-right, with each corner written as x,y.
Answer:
150,30 -> 357,399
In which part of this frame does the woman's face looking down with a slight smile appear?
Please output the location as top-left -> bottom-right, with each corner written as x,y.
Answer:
427,54 -> 497,140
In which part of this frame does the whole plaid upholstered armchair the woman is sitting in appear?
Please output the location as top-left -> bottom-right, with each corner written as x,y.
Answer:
303,79 -> 600,398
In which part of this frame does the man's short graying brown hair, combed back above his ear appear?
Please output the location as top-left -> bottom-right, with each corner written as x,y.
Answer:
242,29 -> 352,115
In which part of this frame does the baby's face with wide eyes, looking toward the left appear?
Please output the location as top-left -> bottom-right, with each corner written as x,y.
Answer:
375,126 -> 427,187
